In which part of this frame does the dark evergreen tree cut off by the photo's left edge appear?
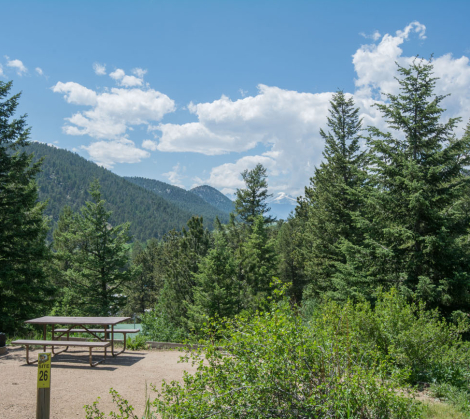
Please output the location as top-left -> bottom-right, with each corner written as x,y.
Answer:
0,81 -> 53,332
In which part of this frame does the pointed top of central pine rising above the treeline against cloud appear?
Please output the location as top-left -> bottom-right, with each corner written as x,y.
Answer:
235,163 -> 276,226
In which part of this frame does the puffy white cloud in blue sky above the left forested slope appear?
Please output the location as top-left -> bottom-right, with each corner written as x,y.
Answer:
52,82 -> 175,140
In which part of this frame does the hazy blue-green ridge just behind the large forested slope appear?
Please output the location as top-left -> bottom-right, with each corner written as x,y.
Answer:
124,177 -> 229,226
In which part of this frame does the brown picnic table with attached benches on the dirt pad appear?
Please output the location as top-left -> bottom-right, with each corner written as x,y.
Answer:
12,316 -> 139,367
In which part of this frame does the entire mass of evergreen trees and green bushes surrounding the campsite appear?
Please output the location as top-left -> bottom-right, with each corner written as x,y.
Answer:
0,58 -> 470,418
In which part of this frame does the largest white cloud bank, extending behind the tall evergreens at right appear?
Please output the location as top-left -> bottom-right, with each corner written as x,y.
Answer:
157,22 -> 470,195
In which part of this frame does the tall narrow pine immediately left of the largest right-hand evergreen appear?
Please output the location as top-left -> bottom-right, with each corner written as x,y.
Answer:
297,91 -> 365,297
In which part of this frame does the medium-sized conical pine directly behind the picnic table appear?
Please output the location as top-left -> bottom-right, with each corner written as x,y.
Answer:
54,181 -> 135,316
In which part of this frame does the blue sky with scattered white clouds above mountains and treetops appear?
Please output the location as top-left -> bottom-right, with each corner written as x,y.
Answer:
0,0 -> 470,196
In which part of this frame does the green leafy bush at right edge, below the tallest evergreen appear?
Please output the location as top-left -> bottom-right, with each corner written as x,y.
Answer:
310,290 -> 470,388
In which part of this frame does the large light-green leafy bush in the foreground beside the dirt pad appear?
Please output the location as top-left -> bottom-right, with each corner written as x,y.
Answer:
154,304 -> 420,418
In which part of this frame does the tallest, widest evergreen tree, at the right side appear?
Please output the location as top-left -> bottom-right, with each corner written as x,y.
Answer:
341,59 -> 470,313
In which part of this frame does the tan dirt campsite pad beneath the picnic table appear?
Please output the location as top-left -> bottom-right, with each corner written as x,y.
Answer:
0,347 -> 194,419
